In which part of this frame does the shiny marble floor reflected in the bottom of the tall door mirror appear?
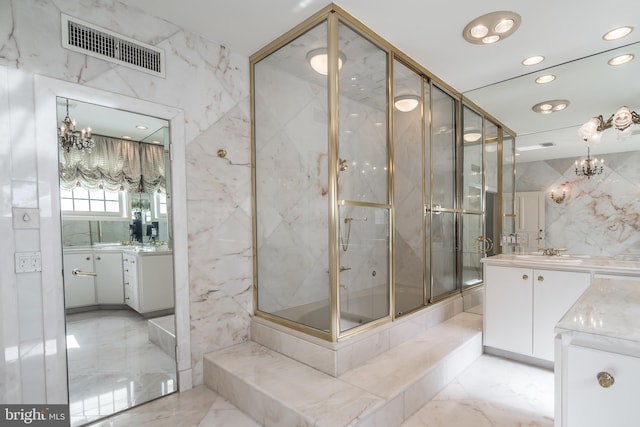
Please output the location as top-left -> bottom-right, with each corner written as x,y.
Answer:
67,310 -> 177,426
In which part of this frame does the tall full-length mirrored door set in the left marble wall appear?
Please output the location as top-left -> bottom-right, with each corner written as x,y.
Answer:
57,98 -> 178,426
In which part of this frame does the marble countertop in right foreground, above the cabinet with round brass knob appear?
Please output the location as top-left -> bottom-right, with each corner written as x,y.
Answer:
556,279 -> 640,342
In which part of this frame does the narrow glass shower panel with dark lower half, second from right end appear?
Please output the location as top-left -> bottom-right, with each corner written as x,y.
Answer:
483,120 -> 500,256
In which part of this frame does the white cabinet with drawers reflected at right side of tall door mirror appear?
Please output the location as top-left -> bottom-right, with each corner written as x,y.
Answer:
122,251 -> 174,313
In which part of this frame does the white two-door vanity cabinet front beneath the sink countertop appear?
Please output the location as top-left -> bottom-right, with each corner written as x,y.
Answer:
484,266 -> 591,361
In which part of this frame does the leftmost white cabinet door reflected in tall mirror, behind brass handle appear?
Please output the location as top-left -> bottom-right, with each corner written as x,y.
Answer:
63,251 -> 96,308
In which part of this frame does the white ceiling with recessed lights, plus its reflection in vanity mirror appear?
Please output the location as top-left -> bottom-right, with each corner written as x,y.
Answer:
115,0 -> 640,161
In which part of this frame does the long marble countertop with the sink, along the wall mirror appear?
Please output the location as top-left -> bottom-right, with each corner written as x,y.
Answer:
481,254 -> 640,276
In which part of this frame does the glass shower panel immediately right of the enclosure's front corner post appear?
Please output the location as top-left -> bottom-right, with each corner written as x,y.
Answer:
337,23 -> 391,334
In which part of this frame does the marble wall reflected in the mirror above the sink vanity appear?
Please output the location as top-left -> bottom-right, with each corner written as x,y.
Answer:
516,151 -> 640,256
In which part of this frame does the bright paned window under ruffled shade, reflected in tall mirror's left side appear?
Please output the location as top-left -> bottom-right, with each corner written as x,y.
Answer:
60,187 -> 126,217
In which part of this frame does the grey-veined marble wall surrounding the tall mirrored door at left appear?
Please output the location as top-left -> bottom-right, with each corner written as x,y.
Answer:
0,0 -> 252,403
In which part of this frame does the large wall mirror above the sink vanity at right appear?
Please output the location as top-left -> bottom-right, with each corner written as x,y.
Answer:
464,42 -> 640,257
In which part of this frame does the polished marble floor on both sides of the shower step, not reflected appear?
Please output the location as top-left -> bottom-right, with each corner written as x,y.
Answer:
89,355 -> 554,427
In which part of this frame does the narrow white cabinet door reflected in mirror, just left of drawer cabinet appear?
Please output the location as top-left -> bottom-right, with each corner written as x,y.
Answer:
94,252 -> 124,304
